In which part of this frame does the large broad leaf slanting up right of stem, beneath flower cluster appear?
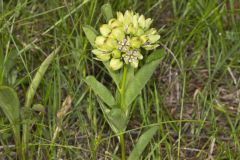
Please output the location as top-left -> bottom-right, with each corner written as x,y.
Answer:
125,60 -> 160,107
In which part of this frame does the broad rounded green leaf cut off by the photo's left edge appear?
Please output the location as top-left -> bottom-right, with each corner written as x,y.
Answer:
0,86 -> 20,147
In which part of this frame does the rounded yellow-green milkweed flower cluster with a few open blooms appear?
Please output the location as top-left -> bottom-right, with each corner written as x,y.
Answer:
92,11 -> 160,70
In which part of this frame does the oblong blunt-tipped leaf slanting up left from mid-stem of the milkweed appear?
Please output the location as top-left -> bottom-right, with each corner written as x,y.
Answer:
85,76 -> 116,107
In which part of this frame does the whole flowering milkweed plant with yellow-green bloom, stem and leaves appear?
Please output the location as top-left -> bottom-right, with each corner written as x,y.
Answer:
83,4 -> 165,159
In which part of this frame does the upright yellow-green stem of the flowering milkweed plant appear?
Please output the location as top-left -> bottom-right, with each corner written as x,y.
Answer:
119,65 -> 127,160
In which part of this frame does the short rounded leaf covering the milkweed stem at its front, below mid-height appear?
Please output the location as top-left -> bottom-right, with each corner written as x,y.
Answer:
107,108 -> 127,133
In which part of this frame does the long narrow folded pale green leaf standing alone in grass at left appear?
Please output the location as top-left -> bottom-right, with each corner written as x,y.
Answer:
24,47 -> 60,107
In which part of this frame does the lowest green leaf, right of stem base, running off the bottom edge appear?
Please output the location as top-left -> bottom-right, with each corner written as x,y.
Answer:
128,126 -> 159,160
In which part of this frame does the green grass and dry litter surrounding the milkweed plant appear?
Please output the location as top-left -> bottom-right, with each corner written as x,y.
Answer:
0,0 -> 240,160
